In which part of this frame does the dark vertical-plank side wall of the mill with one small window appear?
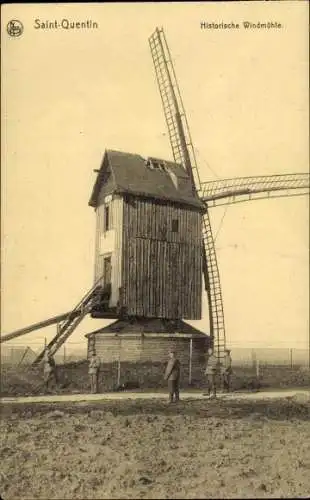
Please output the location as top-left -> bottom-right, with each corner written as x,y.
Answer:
122,196 -> 202,319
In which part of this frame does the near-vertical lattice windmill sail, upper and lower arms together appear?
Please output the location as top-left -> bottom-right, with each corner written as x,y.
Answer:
149,28 -> 226,358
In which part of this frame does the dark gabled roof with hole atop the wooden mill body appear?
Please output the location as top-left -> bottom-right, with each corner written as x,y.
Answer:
89,150 -> 203,209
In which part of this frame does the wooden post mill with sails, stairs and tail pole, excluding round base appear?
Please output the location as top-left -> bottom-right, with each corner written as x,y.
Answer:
1,28 -> 309,363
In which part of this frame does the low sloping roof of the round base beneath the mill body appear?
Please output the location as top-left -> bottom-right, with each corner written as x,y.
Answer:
85,318 -> 208,338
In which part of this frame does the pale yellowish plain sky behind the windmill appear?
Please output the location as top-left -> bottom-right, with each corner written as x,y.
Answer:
1,2 -> 309,349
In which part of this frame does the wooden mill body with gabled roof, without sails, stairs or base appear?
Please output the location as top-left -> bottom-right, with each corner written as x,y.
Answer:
90,151 -> 204,320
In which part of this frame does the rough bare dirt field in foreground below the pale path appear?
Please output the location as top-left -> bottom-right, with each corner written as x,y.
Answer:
0,397 -> 310,500
